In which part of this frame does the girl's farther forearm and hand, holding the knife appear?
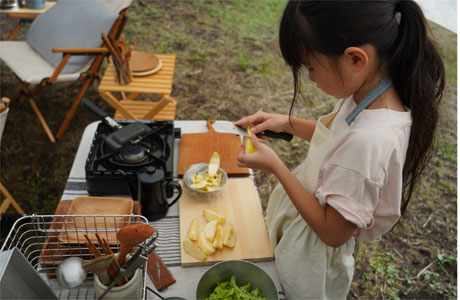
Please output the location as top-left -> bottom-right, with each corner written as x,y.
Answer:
235,111 -> 316,141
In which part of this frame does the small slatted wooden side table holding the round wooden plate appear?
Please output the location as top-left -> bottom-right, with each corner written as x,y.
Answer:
98,54 -> 177,121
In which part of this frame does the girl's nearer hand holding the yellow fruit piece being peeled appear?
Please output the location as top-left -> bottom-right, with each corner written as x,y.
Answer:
237,135 -> 283,173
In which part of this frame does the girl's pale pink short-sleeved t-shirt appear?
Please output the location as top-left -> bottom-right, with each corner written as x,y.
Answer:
315,97 -> 412,242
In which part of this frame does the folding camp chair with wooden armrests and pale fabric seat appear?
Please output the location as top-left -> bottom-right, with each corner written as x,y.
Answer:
0,0 -> 132,143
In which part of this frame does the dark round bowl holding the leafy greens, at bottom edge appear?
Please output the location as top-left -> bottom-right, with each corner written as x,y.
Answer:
196,260 -> 278,299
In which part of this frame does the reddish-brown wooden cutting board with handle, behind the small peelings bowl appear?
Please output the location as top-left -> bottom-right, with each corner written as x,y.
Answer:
177,121 -> 249,177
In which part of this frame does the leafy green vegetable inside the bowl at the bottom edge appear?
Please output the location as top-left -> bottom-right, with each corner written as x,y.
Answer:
206,276 -> 267,300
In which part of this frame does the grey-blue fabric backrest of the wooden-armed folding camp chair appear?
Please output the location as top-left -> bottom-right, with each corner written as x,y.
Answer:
25,0 -> 131,74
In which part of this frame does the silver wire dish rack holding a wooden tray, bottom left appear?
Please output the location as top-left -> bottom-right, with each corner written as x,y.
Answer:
0,214 -> 150,299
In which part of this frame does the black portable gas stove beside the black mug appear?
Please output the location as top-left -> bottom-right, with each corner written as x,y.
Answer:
85,120 -> 180,200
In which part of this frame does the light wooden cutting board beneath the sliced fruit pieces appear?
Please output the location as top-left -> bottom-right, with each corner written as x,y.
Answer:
179,177 -> 273,266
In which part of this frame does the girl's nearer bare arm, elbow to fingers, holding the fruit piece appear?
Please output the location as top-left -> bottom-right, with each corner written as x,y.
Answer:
238,136 -> 356,247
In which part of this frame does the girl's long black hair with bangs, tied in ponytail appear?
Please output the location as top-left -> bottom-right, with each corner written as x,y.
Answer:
279,0 -> 445,213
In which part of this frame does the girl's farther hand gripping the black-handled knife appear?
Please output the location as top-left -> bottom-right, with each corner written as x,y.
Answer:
235,111 -> 289,134
